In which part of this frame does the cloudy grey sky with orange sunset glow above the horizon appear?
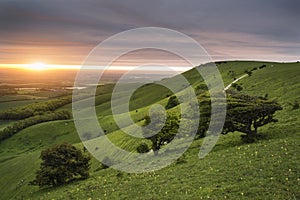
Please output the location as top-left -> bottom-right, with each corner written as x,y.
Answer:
0,0 -> 300,65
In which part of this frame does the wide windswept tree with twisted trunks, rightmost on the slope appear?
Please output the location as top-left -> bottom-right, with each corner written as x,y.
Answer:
223,94 -> 282,142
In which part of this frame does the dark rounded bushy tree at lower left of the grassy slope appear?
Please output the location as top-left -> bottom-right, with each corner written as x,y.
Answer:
31,144 -> 90,187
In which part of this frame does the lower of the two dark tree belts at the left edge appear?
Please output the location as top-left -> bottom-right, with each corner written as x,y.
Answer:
0,110 -> 71,141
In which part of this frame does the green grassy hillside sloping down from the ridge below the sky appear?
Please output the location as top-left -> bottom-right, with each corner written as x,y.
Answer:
0,61 -> 300,199
